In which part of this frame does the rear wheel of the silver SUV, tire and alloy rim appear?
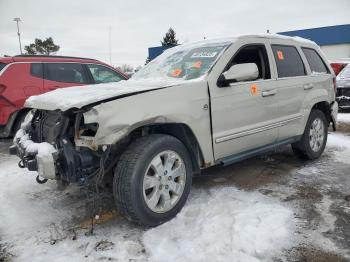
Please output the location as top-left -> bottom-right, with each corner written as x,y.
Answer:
292,109 -> 328,160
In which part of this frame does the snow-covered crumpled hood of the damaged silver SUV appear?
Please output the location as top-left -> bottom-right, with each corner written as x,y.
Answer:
25,79 -> 181,111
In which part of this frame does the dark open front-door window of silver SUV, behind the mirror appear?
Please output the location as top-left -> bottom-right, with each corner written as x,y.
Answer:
226,45 -> 271,79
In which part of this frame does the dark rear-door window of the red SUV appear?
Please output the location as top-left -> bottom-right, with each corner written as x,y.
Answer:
45,63 -> 88,83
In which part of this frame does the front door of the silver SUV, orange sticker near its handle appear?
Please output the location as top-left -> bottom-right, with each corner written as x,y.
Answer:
209,39 -> 277,160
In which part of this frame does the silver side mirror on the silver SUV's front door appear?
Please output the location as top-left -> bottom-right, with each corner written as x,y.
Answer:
223,63 -> 259,83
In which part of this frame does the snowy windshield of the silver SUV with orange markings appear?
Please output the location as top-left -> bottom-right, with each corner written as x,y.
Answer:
131,42 -> 230,80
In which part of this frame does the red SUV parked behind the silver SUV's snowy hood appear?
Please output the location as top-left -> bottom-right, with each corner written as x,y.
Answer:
0,55 -> 128,137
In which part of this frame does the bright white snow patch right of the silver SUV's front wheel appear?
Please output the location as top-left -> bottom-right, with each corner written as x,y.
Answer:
143,187 -> 293,261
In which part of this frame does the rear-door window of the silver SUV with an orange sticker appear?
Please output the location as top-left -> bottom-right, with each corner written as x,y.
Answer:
271,45 -> 306,78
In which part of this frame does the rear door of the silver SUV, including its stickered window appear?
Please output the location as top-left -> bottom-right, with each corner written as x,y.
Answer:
271,43 -> 309,141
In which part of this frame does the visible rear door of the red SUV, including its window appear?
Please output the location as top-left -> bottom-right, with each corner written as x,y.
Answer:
44,63 -> 90,92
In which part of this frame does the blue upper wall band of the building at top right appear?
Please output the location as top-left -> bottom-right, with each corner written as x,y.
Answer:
279,24 -> 350,45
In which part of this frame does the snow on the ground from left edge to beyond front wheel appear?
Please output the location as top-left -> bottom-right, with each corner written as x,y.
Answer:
0,153 -> 294,262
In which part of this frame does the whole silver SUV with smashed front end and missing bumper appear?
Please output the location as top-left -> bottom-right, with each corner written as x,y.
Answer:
10,35 -> 338,226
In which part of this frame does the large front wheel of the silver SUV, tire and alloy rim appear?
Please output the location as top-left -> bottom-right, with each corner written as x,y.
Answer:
113,134 -> 193,227
